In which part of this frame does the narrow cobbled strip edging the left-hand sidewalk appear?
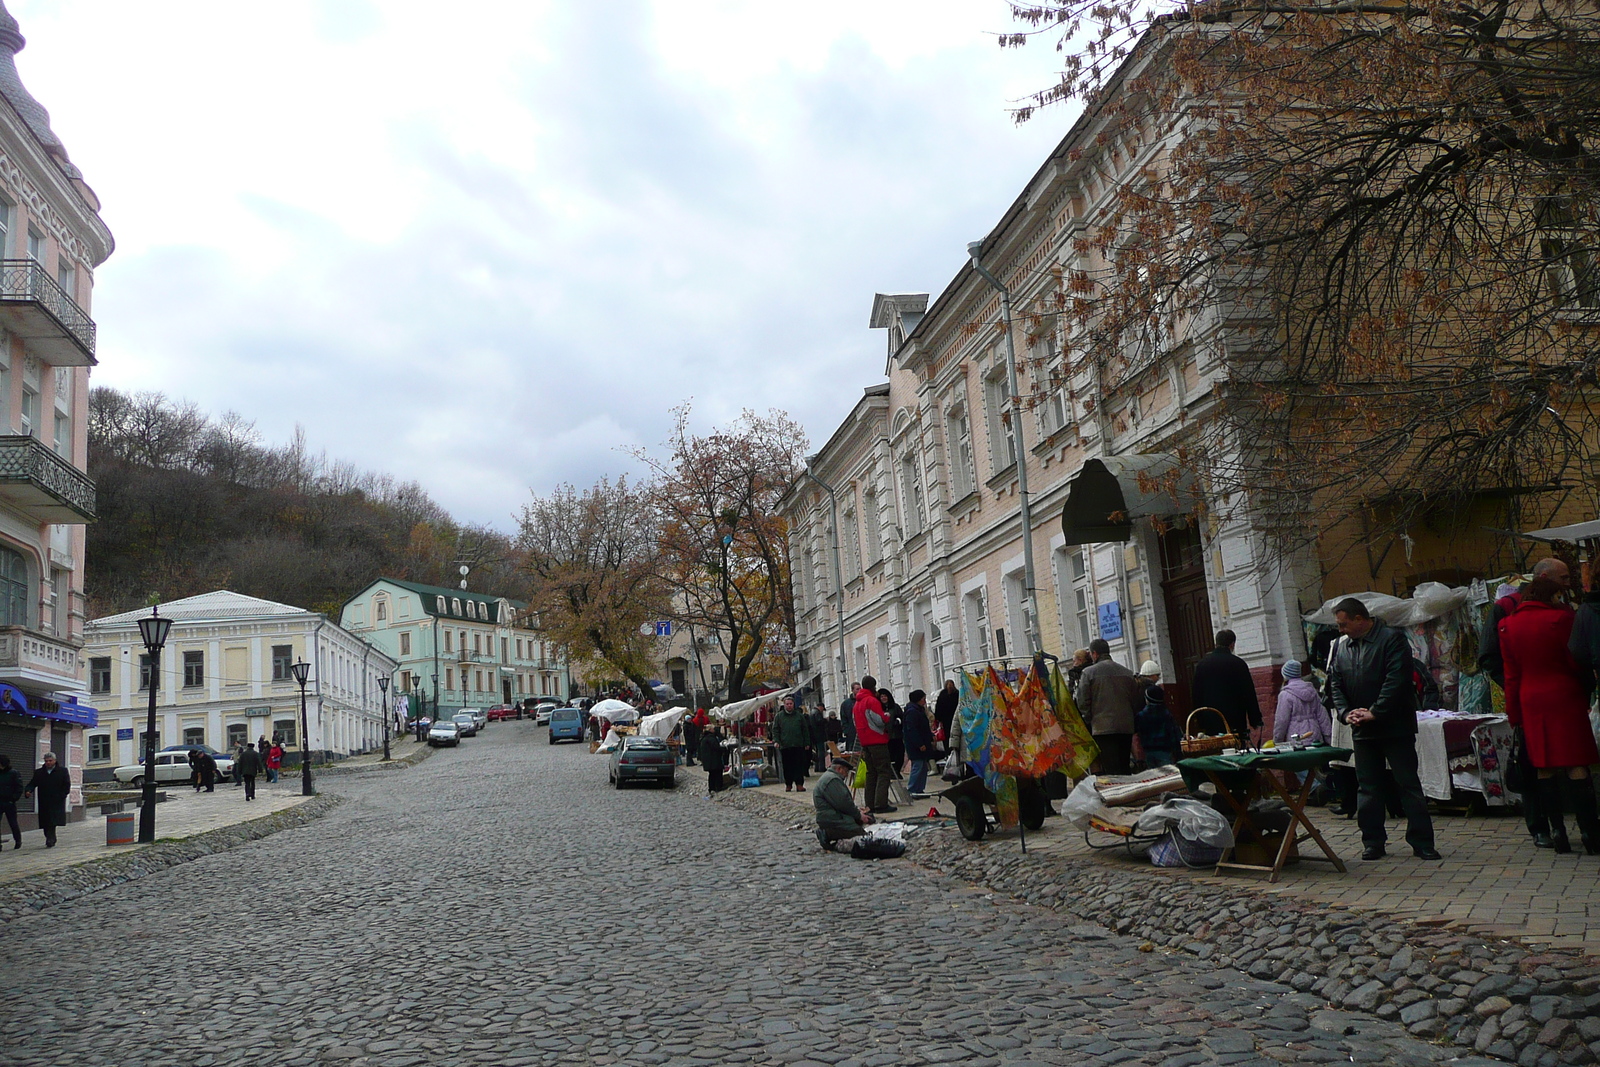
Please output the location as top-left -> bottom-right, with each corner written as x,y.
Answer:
0,793 -> 344,926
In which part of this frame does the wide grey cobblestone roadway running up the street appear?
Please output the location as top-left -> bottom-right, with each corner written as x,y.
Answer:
0,723 -> 1504,1067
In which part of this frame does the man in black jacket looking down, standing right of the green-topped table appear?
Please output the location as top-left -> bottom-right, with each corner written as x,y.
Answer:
1328,597 -> 1438,859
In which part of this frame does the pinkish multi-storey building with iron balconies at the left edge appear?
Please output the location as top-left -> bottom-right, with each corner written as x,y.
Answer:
0,3 -> 112,825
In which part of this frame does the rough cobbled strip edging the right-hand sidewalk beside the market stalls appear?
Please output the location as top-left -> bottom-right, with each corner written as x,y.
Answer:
715,789 -> 1600,1064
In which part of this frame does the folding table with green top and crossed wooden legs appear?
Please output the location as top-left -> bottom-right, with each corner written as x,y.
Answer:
1178,745 -> 1350,881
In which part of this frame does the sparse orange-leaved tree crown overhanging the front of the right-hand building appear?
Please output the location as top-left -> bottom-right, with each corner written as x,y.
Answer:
1002,0 -> 1600,566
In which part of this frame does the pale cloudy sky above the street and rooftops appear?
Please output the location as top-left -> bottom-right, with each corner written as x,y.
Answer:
6,0 -> 1069,530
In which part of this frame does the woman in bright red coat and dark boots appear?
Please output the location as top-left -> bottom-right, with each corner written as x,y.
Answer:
1499,576 -> 1600,856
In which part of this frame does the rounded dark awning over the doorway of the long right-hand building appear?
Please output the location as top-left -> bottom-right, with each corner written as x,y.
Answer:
1061,453 -> 1194,544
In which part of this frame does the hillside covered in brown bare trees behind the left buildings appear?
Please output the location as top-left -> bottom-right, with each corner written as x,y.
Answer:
86,387 -> 522,617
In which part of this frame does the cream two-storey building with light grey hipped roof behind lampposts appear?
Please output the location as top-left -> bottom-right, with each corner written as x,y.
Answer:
83,590 -> 398,781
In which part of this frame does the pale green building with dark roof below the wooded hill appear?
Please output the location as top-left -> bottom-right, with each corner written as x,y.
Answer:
339,577 -> 571,713
